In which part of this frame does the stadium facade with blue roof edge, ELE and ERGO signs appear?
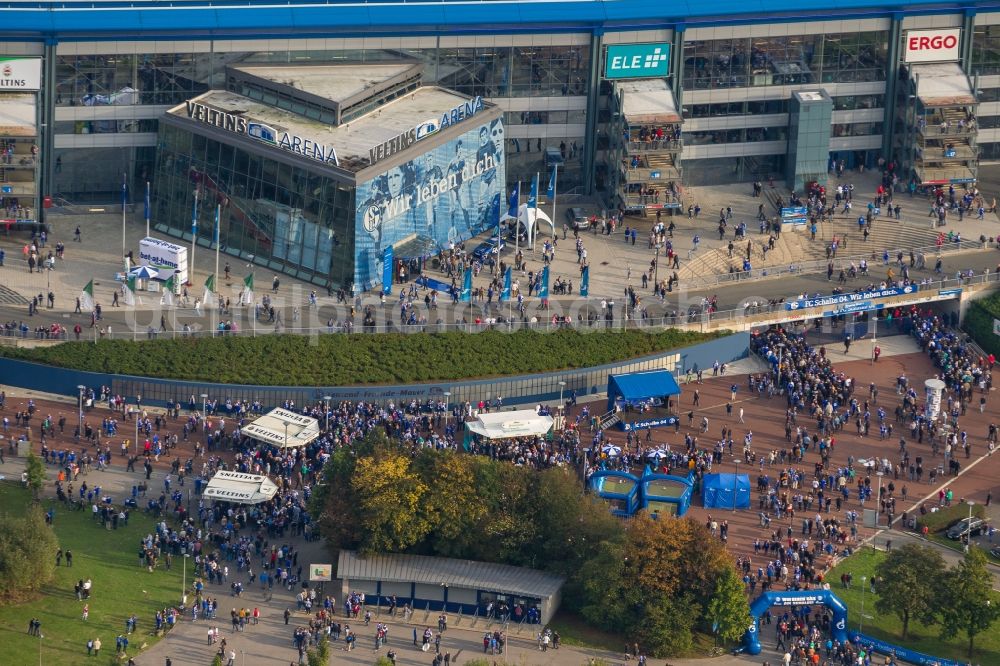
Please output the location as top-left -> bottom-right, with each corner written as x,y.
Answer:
0,0 -> 1000,283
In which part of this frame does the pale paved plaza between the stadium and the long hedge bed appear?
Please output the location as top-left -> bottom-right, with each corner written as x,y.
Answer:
0,173 -> 1000,337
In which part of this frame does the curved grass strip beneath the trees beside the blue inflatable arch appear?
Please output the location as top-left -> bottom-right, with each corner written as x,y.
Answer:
826,548 -> 1000,664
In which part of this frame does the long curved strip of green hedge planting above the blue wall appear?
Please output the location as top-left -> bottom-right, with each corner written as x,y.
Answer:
0,329 -> 721,386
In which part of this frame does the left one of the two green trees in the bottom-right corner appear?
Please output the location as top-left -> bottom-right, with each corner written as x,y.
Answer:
875,543 -> 945,639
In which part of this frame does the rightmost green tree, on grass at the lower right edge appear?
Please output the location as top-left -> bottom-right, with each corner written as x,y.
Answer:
925,548 -> 1000,658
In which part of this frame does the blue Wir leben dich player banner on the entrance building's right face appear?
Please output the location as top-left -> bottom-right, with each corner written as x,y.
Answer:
354,118 -> 507,291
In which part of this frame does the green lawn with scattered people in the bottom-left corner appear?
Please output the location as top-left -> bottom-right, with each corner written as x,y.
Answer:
0,483 -> 186,666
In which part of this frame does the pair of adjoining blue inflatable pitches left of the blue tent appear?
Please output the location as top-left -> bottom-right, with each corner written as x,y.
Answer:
589,466 -> 694,518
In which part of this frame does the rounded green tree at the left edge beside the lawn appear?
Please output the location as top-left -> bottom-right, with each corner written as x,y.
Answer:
0,505 -> 59,602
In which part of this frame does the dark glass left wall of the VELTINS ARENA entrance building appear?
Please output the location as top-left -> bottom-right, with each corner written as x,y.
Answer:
153,125 -> 354,288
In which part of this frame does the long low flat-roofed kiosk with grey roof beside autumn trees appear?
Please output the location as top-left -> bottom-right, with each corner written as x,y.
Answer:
337,550 -> 564,624
